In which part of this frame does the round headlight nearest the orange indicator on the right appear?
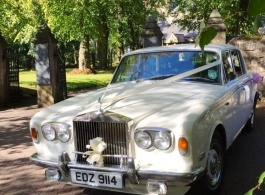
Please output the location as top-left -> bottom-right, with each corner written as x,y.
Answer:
154,132 -> 171,150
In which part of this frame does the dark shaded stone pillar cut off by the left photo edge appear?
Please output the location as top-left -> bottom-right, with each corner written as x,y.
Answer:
0,33 -> 8,108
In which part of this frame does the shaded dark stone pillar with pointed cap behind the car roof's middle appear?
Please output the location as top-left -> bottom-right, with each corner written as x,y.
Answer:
141,15 -> 163,48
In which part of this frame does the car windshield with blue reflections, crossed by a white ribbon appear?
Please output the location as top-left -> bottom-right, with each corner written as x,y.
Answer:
112,51 -> 220,84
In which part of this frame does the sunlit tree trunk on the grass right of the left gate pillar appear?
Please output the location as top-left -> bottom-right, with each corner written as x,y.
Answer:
79,35 -> 92,70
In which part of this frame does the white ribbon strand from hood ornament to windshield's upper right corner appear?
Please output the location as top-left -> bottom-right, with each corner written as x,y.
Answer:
100,60 -> 221,103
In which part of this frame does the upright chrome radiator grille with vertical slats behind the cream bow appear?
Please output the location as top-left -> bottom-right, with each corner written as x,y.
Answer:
73,121 -> 128,165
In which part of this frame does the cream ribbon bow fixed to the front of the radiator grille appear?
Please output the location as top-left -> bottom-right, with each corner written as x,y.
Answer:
83,137 -> 107,165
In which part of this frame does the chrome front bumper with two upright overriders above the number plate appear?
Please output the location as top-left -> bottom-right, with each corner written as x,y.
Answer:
30,152 -> 204,186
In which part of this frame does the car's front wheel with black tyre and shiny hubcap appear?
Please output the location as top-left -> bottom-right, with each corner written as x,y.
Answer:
188,132 -> 224,195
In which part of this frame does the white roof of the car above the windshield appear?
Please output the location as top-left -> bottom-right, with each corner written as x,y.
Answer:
124,43 -> 238,56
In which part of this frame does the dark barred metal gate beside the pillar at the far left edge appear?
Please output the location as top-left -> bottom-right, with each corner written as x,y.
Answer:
5,48 -> 20,105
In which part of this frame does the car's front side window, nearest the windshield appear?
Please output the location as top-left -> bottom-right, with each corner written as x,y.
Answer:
222,51 -> 236,82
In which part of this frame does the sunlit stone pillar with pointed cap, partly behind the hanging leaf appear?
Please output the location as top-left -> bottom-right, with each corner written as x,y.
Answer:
207,9 -> 227,44
